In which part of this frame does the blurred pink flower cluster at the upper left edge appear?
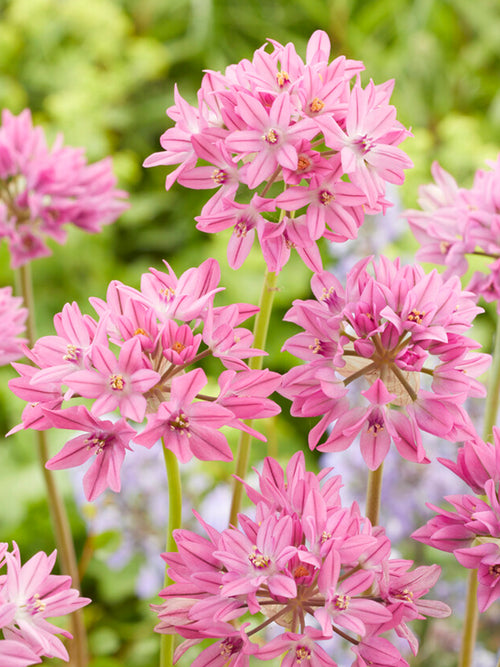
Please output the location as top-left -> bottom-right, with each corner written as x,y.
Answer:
0,109 -> 128,268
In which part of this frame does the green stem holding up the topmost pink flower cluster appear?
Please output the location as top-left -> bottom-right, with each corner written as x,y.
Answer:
229,271 -> 277,526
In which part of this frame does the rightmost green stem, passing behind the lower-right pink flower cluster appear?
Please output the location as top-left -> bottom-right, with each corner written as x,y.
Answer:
459,317 -> 500,667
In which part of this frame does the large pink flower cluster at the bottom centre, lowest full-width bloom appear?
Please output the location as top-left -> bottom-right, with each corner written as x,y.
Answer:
153,452 -> 450,667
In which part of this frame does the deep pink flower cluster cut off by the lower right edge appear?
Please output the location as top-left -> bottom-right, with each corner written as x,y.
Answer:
412,427 -> 500,612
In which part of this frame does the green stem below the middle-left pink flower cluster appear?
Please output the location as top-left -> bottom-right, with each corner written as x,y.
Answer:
160,440 -> 182,667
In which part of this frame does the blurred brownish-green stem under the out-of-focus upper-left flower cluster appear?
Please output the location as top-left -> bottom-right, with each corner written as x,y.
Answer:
18,264 -> 88,667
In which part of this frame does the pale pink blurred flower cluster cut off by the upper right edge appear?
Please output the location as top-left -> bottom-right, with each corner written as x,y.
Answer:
405,155 -> 500,312
